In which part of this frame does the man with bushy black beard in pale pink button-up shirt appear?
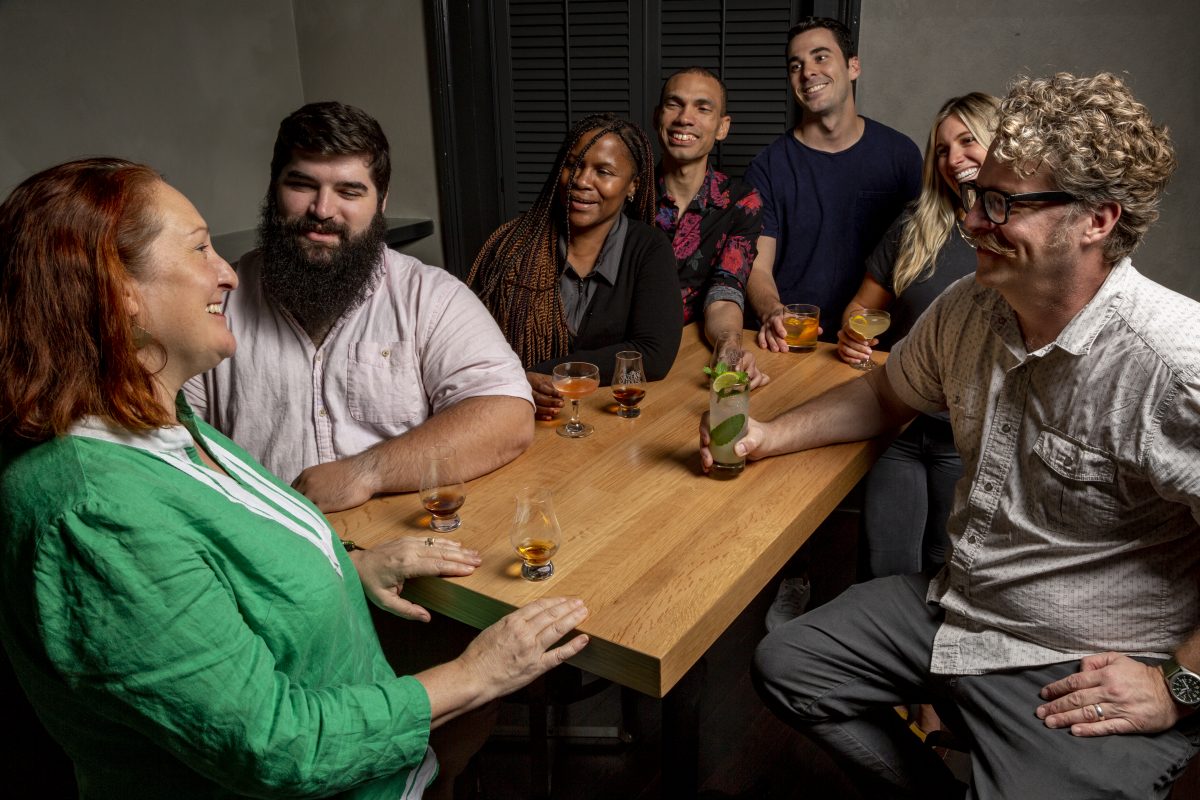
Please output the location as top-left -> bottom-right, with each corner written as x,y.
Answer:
185,102 -> 533,511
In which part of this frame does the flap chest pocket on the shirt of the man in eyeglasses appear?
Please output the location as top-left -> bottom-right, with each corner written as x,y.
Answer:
1031,428 -> 1117,533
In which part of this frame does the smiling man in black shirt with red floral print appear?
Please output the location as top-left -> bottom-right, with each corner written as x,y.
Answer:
654,67 -> 766,385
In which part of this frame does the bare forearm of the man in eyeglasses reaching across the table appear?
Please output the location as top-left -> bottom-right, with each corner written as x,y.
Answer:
760,369 -> 918,456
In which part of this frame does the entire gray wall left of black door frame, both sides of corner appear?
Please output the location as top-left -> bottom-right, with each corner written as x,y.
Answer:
0,0 -> 442,264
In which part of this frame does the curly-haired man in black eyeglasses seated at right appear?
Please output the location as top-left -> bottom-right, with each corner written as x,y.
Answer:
701,73 -> 1200,798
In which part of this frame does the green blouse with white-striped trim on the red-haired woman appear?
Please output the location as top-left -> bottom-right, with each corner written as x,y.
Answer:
0,399 -> 437,800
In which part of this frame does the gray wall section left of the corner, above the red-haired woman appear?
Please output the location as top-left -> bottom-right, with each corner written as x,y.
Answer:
0,0 -> 304,241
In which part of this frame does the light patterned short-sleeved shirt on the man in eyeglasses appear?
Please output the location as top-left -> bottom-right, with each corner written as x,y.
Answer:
887,259 -> 1200,674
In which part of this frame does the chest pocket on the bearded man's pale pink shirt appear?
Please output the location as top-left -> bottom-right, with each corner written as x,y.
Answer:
346,342 -> 428,425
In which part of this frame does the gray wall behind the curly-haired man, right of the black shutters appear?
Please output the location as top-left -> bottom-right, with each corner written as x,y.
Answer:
858,0 -> 1200,299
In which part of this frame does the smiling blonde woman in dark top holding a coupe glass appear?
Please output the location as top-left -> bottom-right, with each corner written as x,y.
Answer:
838,92 -> 1000,577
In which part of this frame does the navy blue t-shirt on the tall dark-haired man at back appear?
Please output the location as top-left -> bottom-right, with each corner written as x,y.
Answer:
745,118 -> 920,341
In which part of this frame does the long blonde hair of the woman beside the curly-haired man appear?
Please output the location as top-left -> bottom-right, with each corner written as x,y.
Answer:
892,91 -> 1000,296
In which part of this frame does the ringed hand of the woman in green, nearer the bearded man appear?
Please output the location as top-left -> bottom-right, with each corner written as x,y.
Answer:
350,536 -> 482,622
